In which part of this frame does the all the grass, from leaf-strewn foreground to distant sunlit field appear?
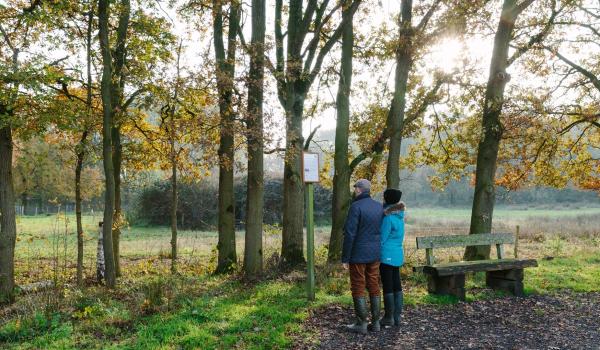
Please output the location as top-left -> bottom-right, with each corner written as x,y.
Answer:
0,208 -> 600,349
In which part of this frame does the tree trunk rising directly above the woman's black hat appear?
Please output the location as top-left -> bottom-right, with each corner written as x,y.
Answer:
385,0 -> 414,188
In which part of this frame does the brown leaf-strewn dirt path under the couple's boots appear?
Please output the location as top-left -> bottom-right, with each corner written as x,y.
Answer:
295,293 -> 600,350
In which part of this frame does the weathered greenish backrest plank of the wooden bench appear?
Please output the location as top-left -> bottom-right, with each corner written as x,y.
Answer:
417,233 -> 515,249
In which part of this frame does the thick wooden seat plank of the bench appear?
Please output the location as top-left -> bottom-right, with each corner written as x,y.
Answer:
423,259 -> 538,276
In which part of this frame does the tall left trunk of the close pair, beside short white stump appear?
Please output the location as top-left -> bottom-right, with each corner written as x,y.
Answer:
98,0 -> 116,288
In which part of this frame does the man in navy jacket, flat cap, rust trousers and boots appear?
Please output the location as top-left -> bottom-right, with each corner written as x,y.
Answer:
342,179 -> 383,334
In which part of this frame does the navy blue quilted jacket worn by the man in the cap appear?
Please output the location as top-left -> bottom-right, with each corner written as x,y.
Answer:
342,193 -> 383,264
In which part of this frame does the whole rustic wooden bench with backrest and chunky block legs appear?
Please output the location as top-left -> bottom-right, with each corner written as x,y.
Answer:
415,233 -> 537,300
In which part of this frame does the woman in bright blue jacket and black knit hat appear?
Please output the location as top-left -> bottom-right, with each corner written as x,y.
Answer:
379,188 -> 405,326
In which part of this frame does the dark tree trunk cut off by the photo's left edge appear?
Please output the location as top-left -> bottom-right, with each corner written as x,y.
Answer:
0,123 -> 17,305
